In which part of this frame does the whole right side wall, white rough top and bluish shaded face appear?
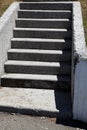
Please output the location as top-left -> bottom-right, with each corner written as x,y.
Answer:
73,2 -> 87,122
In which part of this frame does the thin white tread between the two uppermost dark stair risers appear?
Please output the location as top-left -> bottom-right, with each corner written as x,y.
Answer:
18,9 -> 71,13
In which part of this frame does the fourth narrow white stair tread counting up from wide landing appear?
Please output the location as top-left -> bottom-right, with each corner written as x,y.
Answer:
12,38 -> 66,42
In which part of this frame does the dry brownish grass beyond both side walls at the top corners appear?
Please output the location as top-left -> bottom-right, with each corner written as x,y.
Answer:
0,0 -> 87,43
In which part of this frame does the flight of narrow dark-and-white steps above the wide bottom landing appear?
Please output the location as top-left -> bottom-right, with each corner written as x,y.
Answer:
1,0 -> 72,89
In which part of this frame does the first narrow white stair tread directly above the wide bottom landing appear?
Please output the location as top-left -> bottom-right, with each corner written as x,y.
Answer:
1,73 -> 70,81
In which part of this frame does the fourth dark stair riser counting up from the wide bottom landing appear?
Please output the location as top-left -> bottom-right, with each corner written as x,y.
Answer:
11,41 -> 72,50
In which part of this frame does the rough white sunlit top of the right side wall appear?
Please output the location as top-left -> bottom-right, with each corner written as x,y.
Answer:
73,2 -> 86,59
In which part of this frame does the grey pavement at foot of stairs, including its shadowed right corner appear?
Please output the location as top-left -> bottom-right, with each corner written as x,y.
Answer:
0,113 -> 87,130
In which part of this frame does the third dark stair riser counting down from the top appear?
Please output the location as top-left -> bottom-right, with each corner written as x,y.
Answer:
16,20 -> 71,28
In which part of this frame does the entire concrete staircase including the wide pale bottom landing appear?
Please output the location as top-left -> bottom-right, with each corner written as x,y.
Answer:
0,0 -> 72,120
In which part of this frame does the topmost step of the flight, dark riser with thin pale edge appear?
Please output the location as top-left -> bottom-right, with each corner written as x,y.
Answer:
20,1 -> 72,10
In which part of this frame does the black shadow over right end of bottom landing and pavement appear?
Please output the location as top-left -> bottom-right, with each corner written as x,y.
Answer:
54,90 -> 87,130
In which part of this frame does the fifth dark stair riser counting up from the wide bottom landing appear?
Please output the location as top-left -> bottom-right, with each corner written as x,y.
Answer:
14,30 -> 71,39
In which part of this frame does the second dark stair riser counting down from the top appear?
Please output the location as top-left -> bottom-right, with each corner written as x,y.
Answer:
18,11 -> 71,19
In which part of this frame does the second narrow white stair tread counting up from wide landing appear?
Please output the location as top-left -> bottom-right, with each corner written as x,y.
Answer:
5,60 -> 70,67
